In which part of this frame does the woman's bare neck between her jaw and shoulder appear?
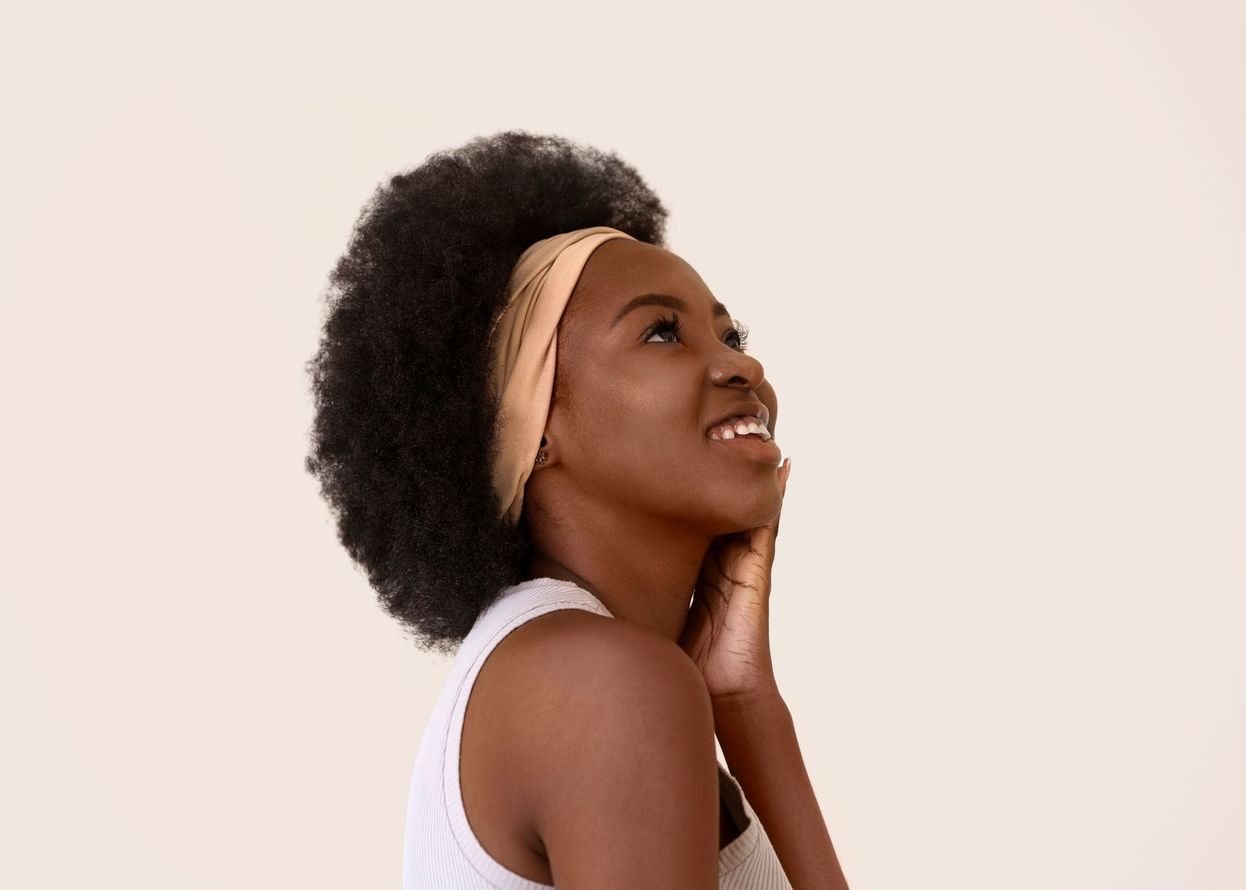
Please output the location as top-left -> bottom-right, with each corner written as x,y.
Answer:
525,511 -> 713,642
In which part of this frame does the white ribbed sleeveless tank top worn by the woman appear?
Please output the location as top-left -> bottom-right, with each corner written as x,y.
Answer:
402,570 -> 791,890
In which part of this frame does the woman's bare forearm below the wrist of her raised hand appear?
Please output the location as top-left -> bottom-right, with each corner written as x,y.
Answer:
714,689 -> 849,890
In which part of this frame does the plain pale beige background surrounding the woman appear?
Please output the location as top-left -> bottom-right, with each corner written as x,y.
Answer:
0,0 -> 1246,890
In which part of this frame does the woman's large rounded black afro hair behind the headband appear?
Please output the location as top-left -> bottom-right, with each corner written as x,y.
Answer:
305,130 -> 667,654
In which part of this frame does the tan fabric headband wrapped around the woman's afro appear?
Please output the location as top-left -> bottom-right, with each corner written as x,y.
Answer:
490,226 -> 635,526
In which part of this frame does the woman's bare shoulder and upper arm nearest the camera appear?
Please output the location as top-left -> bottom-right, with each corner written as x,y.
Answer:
498,610 -> 719,890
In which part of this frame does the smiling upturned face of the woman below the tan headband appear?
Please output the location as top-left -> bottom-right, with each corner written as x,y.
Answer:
540,238 -> 781,535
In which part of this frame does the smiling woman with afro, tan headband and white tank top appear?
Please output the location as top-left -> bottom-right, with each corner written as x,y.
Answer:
308,131 -> 846,890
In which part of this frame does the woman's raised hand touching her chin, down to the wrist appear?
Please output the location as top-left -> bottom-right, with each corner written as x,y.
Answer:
679,459 -> 791,706
